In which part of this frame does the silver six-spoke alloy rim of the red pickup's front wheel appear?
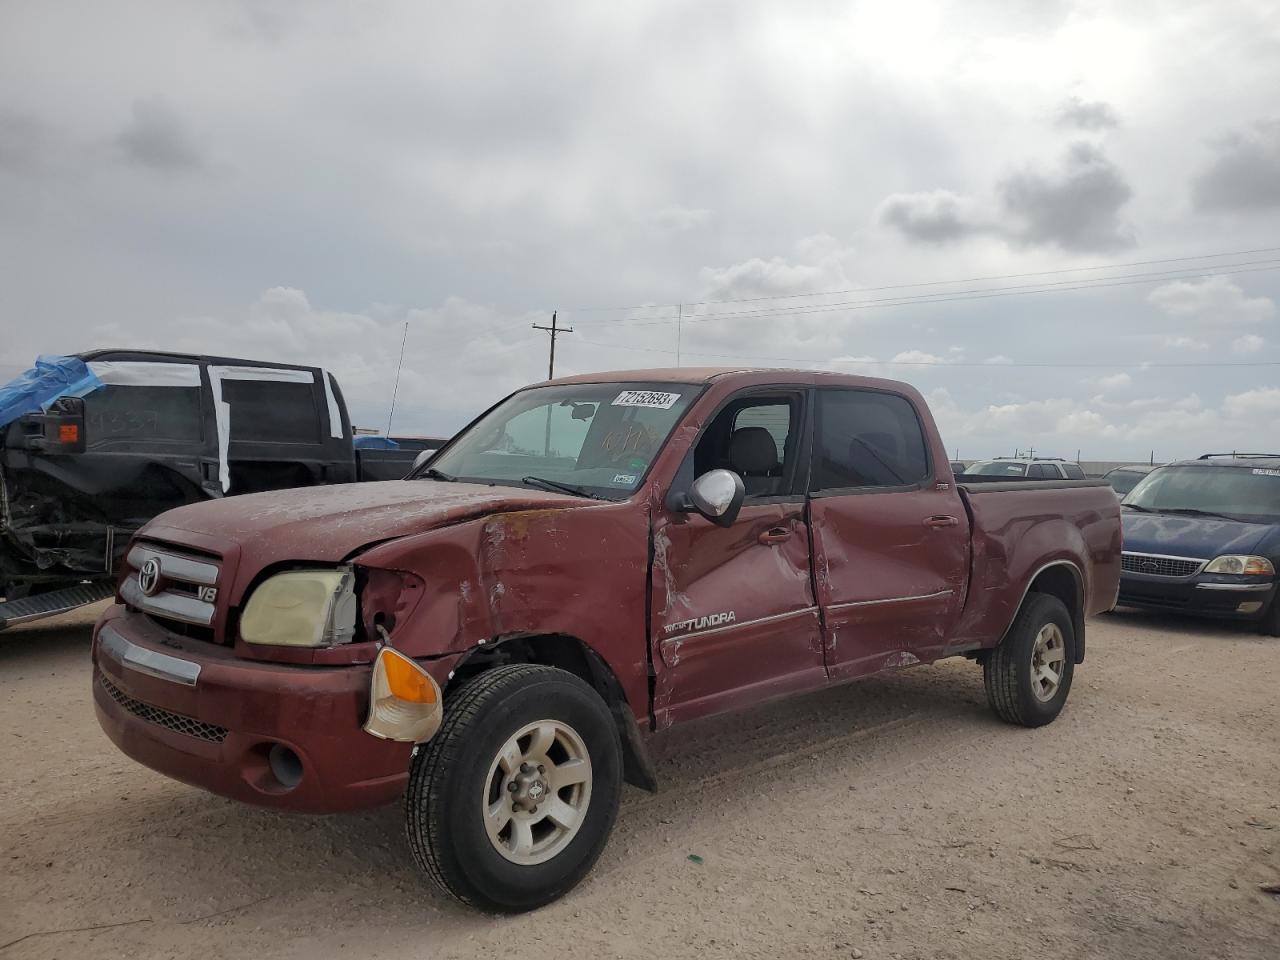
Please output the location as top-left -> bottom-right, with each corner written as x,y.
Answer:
481,719 -> 591,867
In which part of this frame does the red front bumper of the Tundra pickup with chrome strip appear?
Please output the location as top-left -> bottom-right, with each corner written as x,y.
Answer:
93,604 -> 440,813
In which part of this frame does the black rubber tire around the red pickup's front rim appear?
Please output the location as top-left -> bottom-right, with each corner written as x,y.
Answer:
404,663 -> 622,913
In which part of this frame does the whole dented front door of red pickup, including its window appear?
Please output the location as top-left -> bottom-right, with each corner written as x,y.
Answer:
650,390 -> 826,726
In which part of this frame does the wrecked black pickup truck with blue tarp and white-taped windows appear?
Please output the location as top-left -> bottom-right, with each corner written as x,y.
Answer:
0,351 -> 439,630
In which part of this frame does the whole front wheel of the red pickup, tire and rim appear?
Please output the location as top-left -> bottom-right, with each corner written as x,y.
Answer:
404,664 -> 622,913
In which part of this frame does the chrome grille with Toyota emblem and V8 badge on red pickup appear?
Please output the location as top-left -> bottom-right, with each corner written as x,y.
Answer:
120,541 -> 221,640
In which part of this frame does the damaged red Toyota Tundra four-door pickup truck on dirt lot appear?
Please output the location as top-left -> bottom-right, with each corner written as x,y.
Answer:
93,369 -> 1120,911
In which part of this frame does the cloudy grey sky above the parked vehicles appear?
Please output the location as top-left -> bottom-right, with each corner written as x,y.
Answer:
0,0 -> 1280,460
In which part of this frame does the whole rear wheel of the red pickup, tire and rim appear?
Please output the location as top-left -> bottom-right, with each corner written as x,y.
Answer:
983,594 -> 1075,727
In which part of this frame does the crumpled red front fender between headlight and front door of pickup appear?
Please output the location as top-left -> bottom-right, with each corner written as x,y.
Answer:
355,498 -> 649,721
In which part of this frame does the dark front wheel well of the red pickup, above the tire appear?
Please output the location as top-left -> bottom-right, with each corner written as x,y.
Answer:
444,634 -> 658,791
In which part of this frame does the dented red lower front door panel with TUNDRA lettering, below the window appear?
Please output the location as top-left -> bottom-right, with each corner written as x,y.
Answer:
652,503 -> 826,726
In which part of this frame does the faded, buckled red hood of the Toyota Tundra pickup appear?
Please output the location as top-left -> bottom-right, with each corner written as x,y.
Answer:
138,480 -> 595,570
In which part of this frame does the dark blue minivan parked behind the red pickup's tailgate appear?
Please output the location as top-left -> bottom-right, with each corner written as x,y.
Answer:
1120,453 -> 1280,636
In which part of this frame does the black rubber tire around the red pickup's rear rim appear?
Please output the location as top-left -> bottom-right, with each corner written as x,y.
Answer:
982,593 -> 1075,727
